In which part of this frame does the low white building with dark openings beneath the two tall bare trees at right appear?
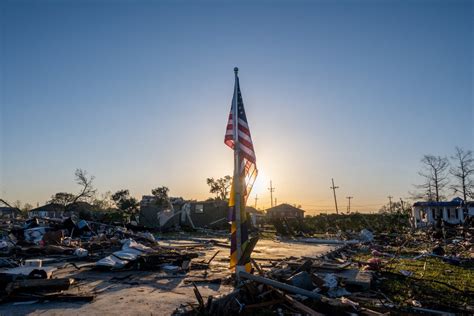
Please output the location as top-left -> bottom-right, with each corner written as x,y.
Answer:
412,197 -> 474,227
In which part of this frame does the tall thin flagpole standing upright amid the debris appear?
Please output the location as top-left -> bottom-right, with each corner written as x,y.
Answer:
232,67 -> 242,276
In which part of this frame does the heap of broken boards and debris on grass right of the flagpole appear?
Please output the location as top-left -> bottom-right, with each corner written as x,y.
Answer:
175,227 -> 474,315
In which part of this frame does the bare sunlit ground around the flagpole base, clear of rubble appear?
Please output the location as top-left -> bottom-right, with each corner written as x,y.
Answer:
0,238 -> 336,316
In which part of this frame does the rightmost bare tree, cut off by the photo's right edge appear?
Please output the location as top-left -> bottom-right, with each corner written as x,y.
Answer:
449,147 -> 474,201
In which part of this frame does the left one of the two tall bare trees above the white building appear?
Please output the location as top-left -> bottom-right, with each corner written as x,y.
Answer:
419,155 -> 449,202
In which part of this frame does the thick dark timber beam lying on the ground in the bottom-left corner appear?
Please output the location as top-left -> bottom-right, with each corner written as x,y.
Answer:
6,278 -> 74,293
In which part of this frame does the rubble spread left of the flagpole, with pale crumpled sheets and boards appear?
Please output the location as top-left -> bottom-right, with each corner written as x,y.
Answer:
0,218 -> 198,303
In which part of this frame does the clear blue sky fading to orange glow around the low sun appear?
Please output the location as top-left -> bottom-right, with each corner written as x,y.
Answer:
0,0 -> 474,212
